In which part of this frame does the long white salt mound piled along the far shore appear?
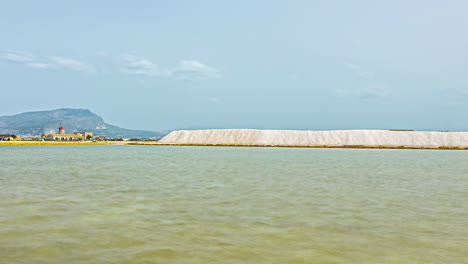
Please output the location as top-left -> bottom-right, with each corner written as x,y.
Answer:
159,129 -> 468,148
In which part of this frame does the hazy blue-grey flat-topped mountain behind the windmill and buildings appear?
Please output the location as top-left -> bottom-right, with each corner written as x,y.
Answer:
0,108 -> 162,139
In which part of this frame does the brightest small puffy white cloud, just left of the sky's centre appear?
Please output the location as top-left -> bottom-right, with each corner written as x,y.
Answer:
169,60 -> 222,80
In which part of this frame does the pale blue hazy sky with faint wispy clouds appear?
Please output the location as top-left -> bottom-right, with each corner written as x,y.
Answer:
0,0 -> 468,131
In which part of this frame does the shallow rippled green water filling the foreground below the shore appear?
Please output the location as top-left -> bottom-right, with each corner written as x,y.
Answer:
0,146 -> 468,264
